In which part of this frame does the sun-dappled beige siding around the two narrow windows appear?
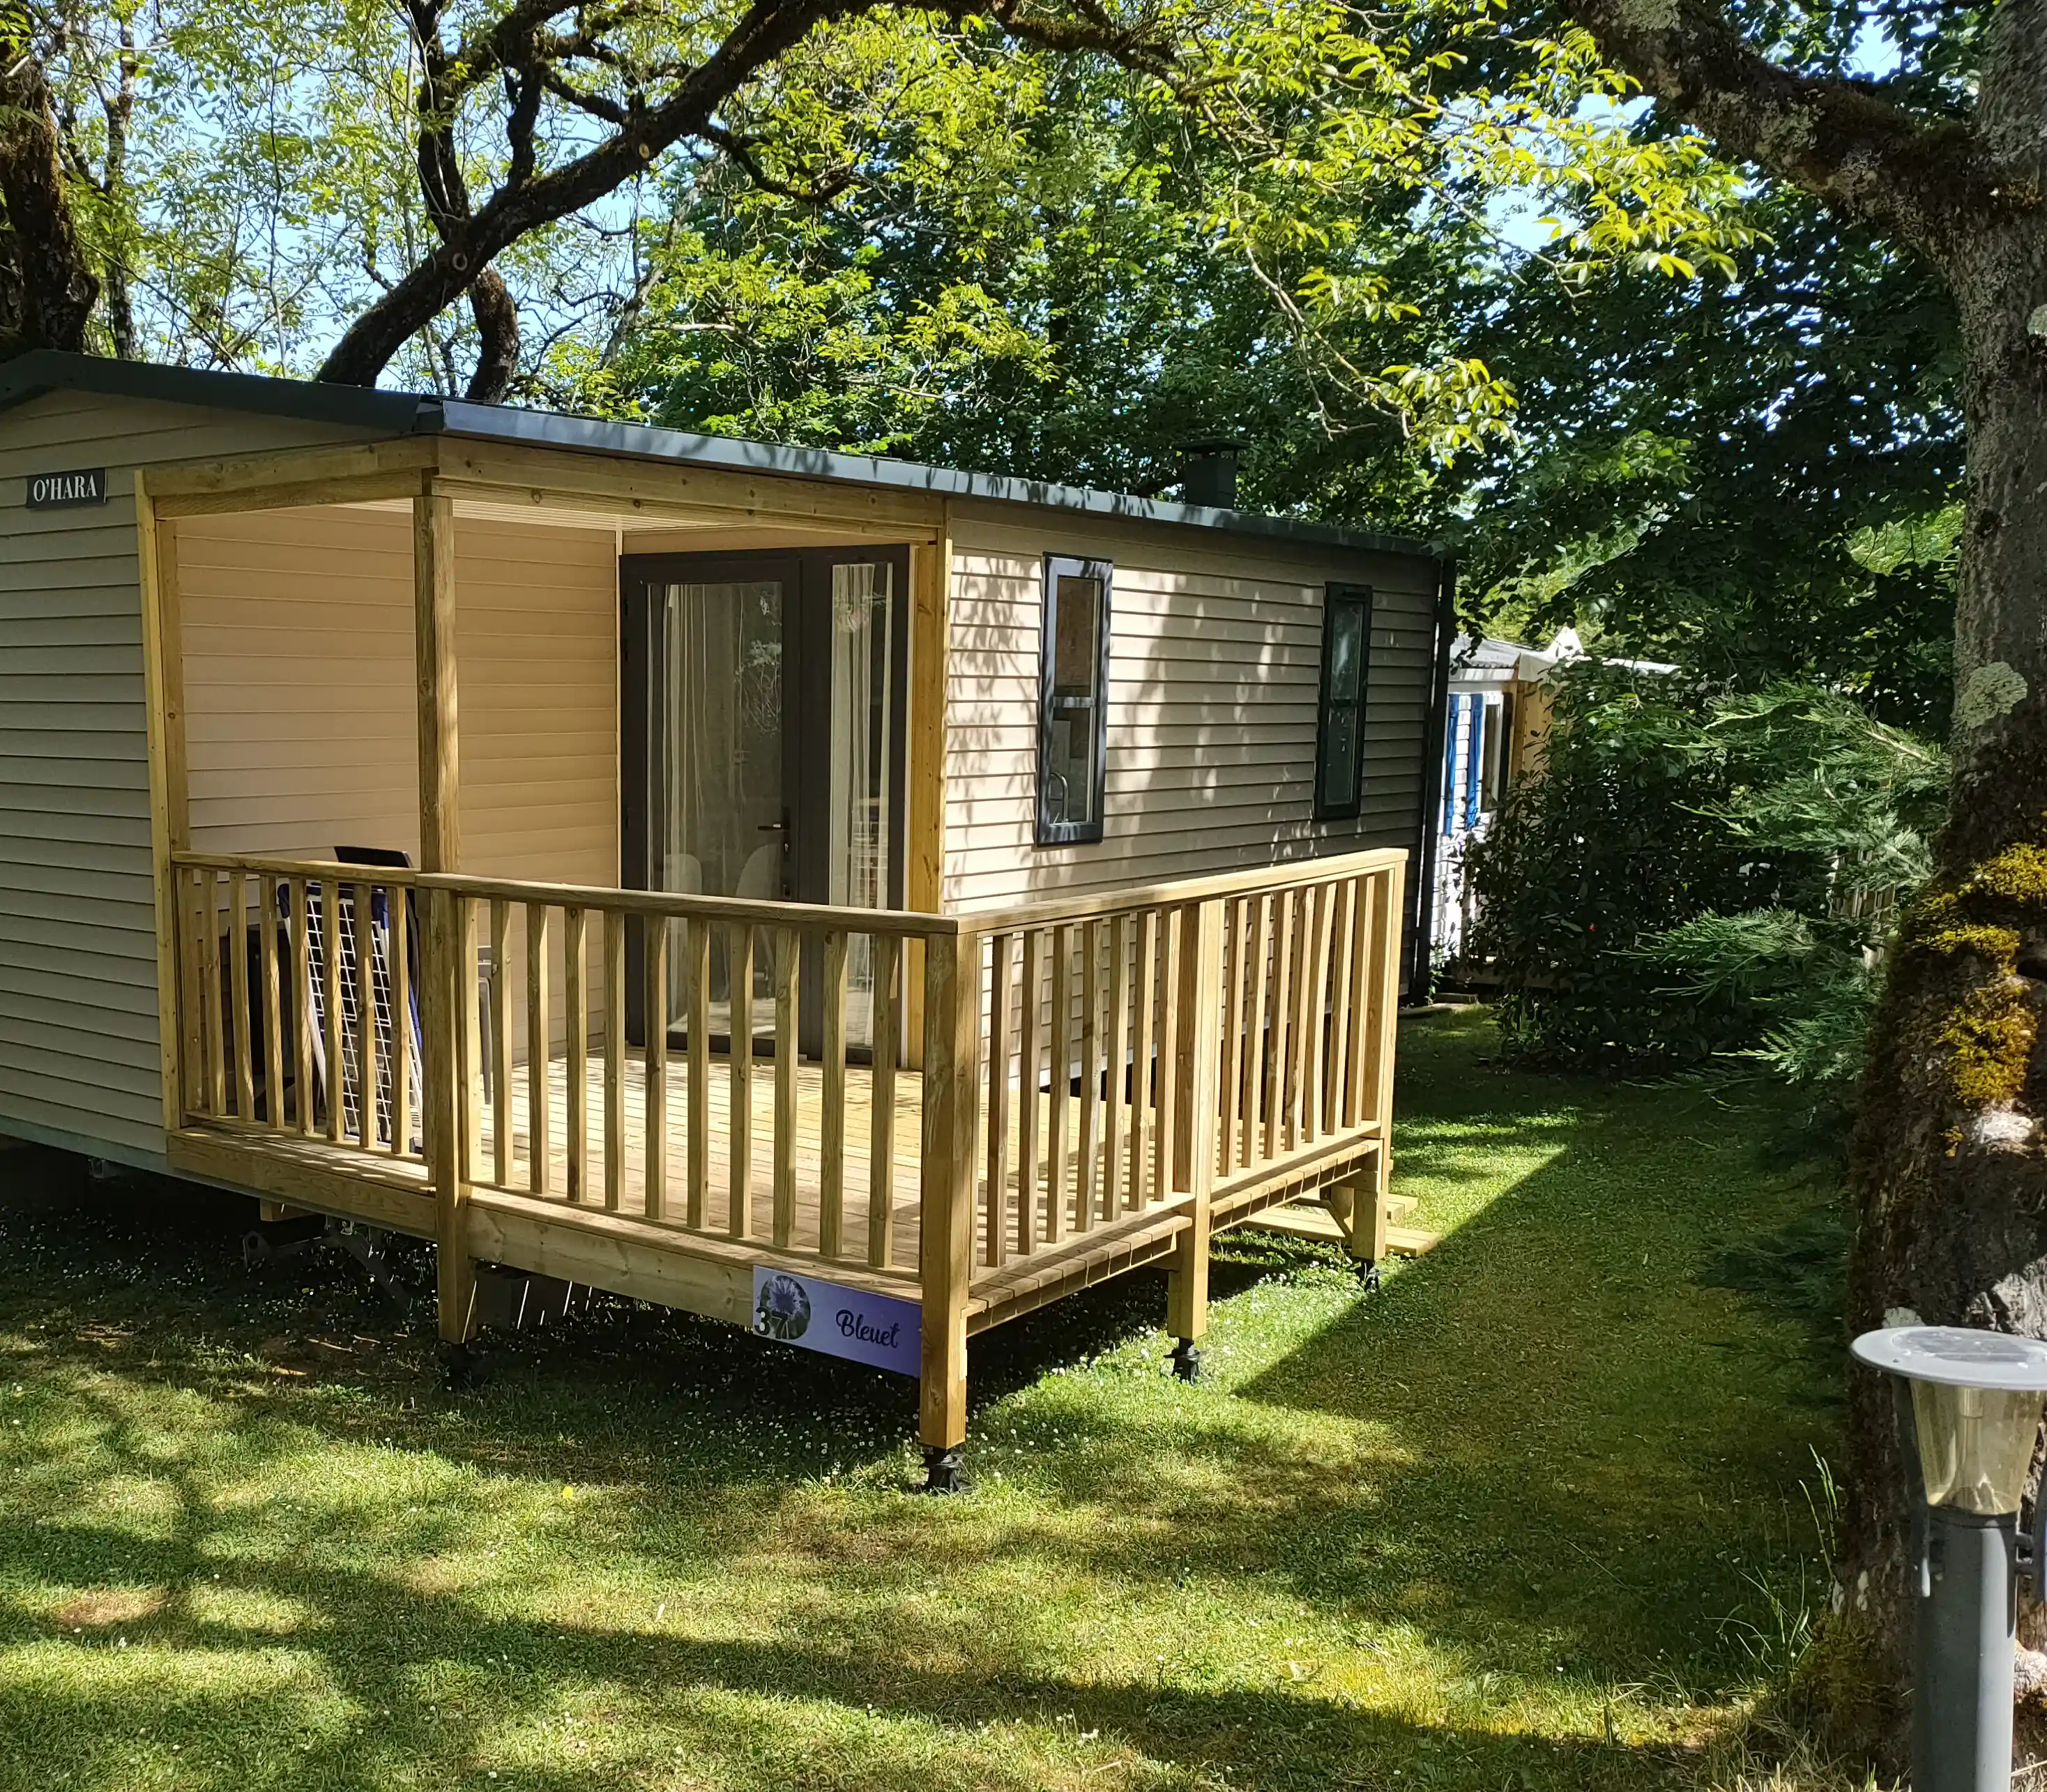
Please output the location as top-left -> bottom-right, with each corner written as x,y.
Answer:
945,504 -> 1435,911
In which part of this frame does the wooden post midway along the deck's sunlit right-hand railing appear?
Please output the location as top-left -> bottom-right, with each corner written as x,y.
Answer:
1159,899 -> 1222,1381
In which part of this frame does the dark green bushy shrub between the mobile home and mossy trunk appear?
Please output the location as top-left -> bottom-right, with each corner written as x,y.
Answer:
1472,666 -> 1947,1090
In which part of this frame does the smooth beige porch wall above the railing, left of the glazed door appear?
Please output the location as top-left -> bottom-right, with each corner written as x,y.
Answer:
178,510 -> 618,885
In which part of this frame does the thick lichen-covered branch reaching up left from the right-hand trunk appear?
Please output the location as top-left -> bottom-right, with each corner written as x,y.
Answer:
1566,0 -> 2014,266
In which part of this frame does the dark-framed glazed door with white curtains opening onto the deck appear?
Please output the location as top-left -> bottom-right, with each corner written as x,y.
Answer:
621,549 -> 909,1049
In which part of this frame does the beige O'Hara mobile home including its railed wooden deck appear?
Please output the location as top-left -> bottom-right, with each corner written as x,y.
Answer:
0,352 -> 1447,1460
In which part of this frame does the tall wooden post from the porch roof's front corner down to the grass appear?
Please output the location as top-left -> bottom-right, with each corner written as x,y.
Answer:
411,494 -> 471,1350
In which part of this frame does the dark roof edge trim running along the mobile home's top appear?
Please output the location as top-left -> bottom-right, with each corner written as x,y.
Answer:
0,348 -> 1441,559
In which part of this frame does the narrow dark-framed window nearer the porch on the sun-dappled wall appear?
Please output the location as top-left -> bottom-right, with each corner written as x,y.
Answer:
1038,553 -> 1109,846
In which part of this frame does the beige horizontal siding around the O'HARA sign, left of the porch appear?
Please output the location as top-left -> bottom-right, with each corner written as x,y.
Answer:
0,393 -> 376,1163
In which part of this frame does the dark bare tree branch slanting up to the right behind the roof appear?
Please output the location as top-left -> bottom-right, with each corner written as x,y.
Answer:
317,0 -> 1173,385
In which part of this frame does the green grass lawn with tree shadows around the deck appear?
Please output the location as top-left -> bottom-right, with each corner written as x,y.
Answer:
0,1014 -> 1840,1792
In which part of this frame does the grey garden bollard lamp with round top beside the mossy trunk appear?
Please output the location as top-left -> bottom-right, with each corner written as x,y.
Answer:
1855,1325 -> 2047,1792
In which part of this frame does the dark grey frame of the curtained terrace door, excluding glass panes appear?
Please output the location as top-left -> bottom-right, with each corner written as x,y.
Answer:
618,542 -> 913,1051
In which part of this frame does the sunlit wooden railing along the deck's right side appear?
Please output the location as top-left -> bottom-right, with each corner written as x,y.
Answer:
968,852 -> 1404,1270
